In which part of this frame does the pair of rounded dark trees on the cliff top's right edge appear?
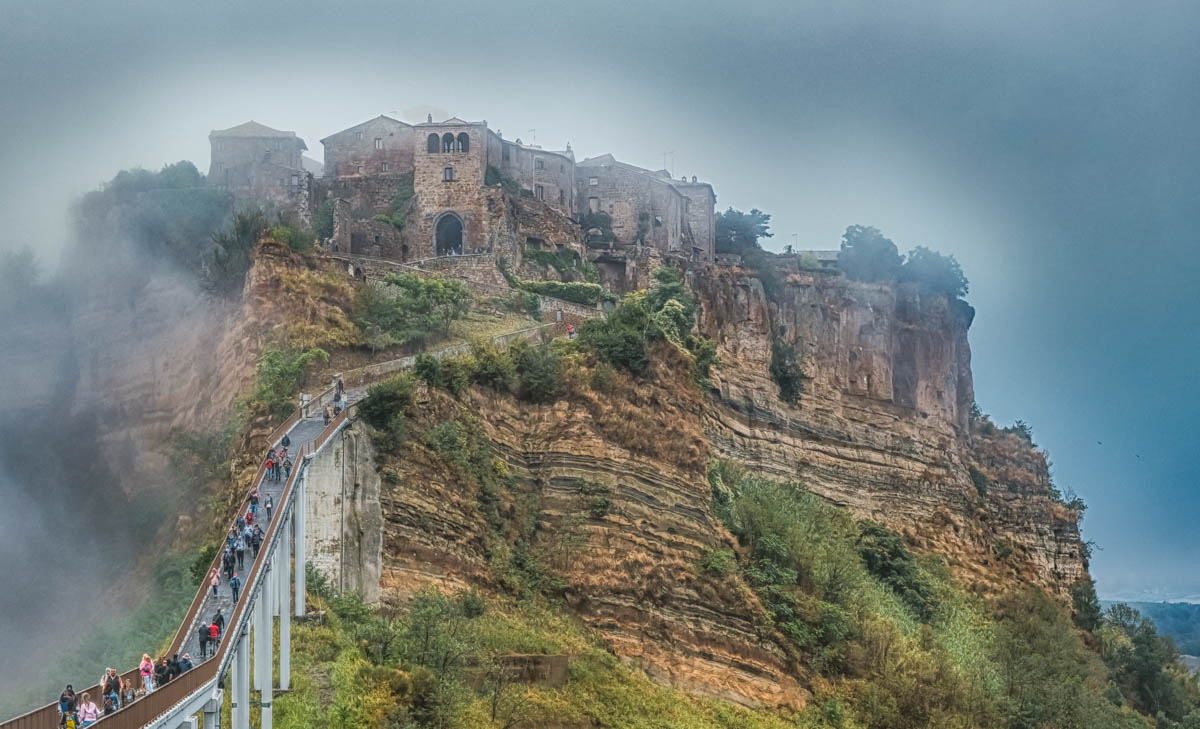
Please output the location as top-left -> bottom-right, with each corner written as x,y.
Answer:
838,225 -> 968,299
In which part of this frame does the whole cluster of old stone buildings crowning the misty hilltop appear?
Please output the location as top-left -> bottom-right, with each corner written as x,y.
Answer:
208,115 -> 716,290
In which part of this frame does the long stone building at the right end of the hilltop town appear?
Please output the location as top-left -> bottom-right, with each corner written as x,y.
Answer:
575,155 -> 716,261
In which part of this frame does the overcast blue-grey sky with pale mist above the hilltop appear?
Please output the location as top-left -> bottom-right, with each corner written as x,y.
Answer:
0,0 -> 1200,597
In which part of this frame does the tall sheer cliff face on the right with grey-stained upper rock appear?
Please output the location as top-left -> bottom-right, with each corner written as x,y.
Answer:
694,269 -> 1085,595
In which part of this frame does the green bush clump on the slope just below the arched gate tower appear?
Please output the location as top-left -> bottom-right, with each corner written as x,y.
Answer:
354,273 -> 472,351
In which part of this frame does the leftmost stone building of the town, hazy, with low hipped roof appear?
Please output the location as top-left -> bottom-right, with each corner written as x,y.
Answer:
209,121 -> 311,216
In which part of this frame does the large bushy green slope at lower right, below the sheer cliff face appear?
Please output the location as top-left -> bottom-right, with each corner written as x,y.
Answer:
702,463 -> 1185,729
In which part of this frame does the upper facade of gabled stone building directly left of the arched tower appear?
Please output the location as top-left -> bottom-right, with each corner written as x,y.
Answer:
320,116 -> 415,177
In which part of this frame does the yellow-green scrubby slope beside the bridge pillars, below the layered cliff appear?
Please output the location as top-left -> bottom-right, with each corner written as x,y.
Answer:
271,587 -> 792,729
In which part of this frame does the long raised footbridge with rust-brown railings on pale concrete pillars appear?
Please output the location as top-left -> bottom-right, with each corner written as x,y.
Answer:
0,321 -> 576,729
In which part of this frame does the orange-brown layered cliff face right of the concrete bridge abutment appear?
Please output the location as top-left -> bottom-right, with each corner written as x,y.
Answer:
382,362 -> 806,706
